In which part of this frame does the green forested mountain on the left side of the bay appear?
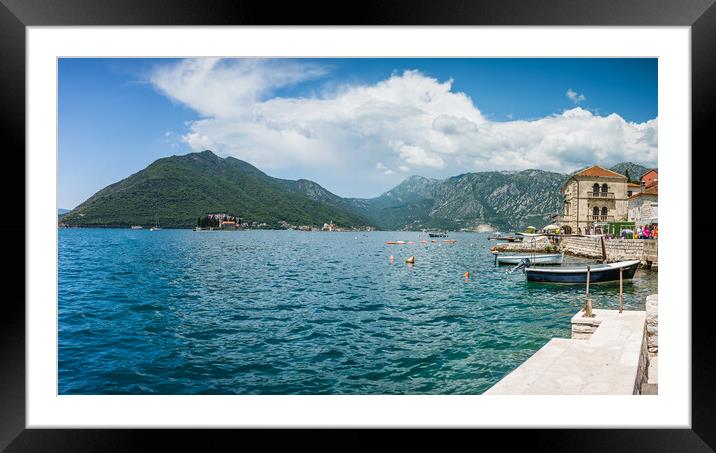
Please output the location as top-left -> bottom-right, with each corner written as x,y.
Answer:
62,151 -> 369,227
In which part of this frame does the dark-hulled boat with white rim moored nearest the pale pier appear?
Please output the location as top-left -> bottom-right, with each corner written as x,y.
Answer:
524,258 -> 639,283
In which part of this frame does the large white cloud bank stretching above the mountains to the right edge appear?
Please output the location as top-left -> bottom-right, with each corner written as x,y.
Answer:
151,59 -> 658,195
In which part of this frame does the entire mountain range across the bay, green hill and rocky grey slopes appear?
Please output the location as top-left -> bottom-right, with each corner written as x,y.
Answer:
61,150 -> 648,230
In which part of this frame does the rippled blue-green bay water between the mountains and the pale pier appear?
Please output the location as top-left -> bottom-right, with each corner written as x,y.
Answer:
58,229 -> 657,394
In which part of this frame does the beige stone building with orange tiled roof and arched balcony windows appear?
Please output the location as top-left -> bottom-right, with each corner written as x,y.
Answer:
557,165 -> 627,234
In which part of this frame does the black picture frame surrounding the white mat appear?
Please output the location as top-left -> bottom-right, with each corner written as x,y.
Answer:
0,0 -> 716,451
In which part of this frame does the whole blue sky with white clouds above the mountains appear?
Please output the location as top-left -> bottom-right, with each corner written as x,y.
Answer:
58,58 -> 658,209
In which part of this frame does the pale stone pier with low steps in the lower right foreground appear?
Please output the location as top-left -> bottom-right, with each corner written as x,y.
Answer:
484,294 -> 658,395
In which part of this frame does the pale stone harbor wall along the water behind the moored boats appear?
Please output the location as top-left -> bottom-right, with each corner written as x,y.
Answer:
560,236 -> 658,270
